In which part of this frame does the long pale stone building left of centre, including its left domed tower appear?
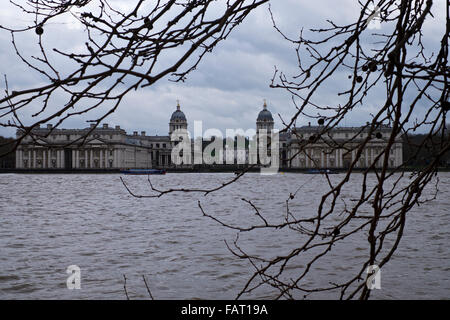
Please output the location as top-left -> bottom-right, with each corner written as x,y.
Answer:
16,104 -> 187,169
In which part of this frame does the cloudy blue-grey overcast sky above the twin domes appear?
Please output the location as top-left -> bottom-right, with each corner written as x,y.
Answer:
0,0 -> 445,136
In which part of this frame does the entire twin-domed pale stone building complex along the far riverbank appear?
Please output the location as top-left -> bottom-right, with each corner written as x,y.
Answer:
16,101 -> 403,169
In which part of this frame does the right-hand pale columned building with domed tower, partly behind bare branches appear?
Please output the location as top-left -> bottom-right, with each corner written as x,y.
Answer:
253,102 -> 403,169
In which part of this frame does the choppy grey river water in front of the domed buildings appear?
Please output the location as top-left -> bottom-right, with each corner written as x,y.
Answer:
0,173 -> 450,299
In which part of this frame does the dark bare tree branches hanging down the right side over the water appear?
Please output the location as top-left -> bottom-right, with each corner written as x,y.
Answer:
122,0 -> 450,299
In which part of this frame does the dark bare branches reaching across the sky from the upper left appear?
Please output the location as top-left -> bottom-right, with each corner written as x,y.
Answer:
0,0 -> 268,152
